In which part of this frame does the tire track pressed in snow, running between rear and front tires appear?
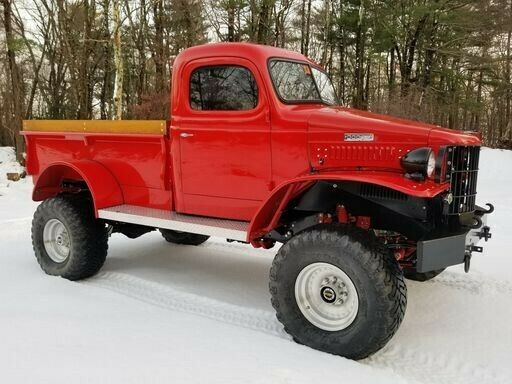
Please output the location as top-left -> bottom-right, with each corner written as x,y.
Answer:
83,272 -> 290,339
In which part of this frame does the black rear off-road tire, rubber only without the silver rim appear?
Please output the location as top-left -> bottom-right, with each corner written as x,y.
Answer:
32,196 -> 108,280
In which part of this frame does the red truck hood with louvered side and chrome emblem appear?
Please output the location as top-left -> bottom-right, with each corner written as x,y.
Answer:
308,107 -> 481,171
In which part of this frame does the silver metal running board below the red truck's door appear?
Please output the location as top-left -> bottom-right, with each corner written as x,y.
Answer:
98,205 -> 249,241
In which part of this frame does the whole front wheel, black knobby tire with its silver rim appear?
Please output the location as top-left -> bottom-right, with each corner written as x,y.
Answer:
270,225 -> 407,359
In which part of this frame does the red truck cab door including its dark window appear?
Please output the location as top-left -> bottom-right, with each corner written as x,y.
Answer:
173,58 -> 271,220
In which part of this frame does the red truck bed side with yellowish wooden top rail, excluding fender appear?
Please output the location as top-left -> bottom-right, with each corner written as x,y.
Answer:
22,120 -> 172,210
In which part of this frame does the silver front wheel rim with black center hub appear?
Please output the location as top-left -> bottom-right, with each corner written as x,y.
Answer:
295,263 -> 359,332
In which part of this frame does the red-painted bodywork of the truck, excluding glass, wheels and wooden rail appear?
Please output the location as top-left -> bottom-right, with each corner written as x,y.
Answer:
24,43 -> 481,246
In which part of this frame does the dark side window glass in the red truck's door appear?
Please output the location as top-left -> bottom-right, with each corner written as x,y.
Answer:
190,66 -> 258,111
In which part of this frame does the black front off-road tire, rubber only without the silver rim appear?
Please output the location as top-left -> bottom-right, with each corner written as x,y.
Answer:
270,224 -> 407,360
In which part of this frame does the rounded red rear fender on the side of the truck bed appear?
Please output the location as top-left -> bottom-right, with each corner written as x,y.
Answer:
32,160 -> 124,216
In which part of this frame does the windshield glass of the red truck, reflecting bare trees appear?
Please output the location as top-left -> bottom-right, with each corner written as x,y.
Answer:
270,60 -> 337,105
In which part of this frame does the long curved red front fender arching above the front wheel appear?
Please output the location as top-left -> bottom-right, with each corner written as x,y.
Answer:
247,171 -> 450,243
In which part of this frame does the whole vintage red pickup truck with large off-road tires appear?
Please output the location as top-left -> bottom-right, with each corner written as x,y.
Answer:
23,43 -> 493,359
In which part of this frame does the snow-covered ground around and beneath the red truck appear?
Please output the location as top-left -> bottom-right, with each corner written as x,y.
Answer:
0,149 -> 512,384
